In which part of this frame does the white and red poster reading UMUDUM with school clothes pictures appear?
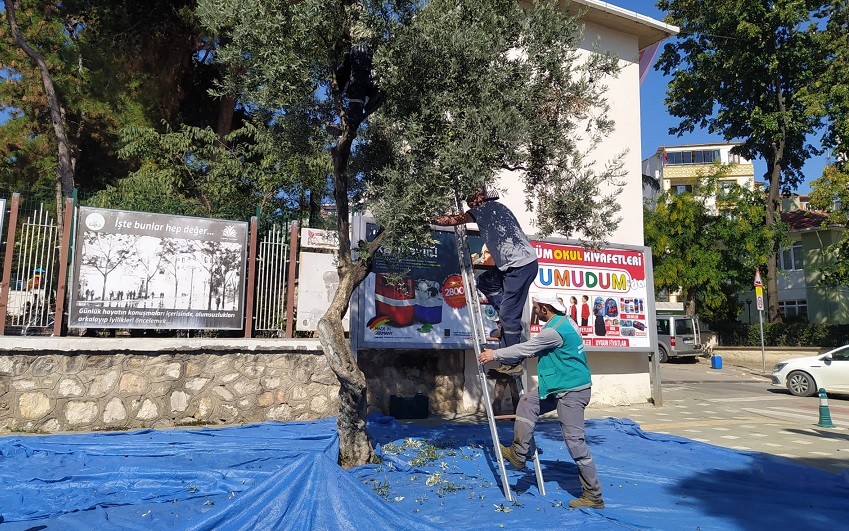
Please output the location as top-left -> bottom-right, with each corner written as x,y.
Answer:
530,241 -> 654,351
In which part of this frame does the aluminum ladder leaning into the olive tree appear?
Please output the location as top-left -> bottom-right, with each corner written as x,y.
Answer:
454,218 -> 545,502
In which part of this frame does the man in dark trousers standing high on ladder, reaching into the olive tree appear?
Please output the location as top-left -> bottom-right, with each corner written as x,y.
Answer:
433,188 -> 539,376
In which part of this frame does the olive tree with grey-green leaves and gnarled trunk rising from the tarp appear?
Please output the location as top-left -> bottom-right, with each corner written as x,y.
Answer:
198,0 -> 621,466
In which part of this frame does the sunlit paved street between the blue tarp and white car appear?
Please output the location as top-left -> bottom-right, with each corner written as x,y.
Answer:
587,359 -> 849,473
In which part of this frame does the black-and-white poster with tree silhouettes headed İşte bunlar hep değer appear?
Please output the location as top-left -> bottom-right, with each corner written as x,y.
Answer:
68,207 -> 248,330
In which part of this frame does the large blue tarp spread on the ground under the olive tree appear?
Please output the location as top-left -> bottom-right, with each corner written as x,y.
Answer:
0,416 -> 849,531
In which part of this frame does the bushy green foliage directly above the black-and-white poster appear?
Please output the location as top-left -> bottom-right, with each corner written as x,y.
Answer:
87,119 -> 330,223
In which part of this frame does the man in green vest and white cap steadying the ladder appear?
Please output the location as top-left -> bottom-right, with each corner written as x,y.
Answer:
478,294 -> 604,509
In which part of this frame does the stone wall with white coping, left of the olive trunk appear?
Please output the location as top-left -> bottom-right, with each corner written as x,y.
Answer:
0,338 -> 339,433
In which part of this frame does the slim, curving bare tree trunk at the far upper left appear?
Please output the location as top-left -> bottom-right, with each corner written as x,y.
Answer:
6,0 -> 74,229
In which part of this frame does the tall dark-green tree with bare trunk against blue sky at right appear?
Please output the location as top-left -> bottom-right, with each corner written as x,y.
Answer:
656,0 -> 828,321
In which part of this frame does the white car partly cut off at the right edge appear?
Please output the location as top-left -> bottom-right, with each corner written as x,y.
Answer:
772,345 -> 849,396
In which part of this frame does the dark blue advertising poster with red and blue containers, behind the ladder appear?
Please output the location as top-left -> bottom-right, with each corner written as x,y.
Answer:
354,223 -> 497,349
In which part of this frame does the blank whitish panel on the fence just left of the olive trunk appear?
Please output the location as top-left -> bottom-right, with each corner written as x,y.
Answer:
296,252 -> 351,332
